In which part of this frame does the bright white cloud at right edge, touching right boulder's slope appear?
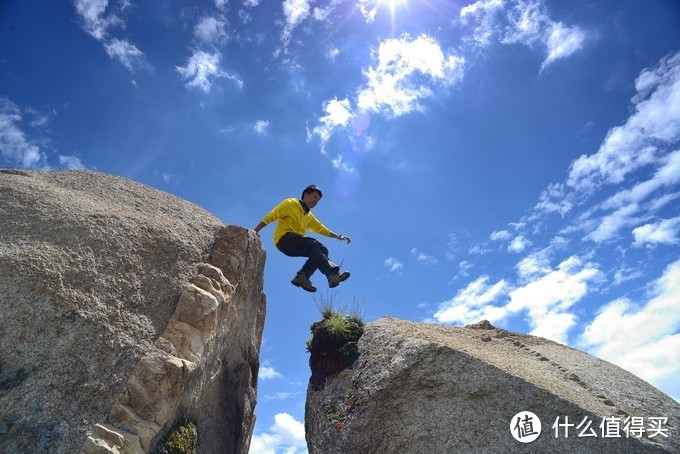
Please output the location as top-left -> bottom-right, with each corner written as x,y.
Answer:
582,261 -> 680,383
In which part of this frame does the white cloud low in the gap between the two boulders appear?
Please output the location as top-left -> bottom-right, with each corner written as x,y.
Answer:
249,413 -> 307,454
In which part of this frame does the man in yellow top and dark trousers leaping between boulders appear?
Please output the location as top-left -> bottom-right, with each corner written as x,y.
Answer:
254,184 -> 352,292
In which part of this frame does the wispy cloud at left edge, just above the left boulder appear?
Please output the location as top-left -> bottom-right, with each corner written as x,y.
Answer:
0,98 -> 49,170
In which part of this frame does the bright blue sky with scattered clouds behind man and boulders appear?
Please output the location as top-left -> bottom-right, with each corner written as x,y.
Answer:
0,0 -> 680,453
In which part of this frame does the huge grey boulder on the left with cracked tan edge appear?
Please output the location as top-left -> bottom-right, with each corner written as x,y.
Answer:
0,170 -> 265,453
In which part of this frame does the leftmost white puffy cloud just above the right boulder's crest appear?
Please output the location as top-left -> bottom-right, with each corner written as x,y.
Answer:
434,276 -> 508,324
